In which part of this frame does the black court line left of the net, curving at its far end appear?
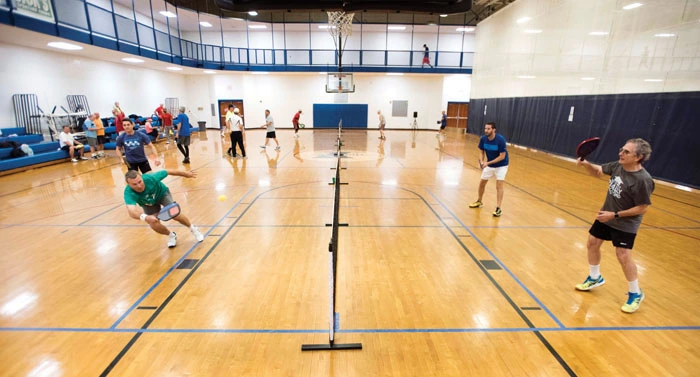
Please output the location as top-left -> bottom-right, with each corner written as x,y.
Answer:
100,182 -> 322,377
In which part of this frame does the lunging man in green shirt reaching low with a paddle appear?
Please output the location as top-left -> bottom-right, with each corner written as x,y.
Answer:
124,170 -> 204,247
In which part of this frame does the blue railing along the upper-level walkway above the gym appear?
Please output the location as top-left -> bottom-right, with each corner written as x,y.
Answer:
0,0 -> 474,73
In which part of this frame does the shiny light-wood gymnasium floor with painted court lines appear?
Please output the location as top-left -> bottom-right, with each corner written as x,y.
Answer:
0,129 -> 700,376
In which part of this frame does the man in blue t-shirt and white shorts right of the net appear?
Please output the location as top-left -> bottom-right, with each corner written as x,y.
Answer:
469,122 -> 508,217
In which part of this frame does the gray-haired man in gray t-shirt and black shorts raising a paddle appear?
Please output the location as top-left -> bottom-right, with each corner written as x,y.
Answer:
576,139 -> 654,313
